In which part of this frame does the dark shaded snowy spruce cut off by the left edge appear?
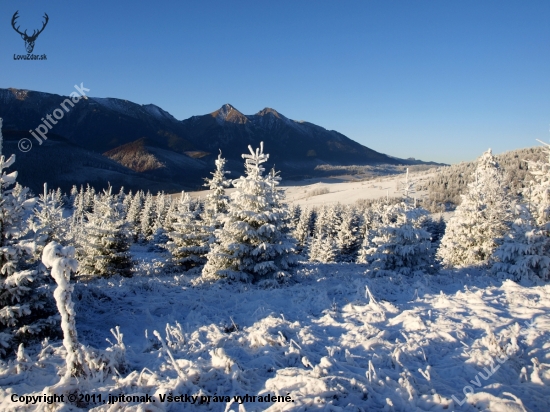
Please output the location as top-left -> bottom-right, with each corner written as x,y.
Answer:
0,119 -> 57,356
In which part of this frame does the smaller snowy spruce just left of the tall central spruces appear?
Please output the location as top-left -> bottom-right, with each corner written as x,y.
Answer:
166,193 -> 210,270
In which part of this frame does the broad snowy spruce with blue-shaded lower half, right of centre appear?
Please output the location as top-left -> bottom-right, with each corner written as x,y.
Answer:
360,202 -> 434,275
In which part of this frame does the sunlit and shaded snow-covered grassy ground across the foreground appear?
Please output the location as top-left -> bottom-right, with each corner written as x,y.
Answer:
0,246 -> 550,411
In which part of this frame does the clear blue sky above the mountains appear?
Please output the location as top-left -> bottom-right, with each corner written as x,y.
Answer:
0,0 -> 550,163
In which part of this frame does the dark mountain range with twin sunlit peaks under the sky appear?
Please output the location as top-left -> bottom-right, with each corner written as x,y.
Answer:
0,88 -> 436,192
